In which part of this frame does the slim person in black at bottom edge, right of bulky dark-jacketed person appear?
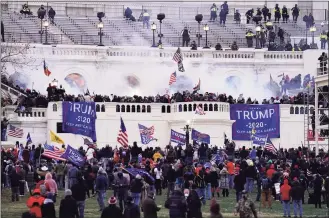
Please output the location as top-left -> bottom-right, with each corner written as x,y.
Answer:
186,185 -> 202,218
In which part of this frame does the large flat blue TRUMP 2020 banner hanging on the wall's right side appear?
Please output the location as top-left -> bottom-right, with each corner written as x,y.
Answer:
230,104 -> 280,140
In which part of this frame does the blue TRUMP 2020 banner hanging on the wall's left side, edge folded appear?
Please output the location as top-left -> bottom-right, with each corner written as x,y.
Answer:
62,101 -> 96,142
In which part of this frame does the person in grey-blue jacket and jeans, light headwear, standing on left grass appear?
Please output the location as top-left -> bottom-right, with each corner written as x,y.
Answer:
96,167 -> 109,211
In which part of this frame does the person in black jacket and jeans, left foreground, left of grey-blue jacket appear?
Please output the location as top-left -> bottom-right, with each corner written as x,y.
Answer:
71,176 -> 88,218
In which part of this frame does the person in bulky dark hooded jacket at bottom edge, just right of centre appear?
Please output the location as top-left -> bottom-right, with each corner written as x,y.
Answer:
165,190 -> 187,218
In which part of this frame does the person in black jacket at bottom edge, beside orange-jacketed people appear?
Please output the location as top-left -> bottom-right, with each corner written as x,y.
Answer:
59,189 -> 79,218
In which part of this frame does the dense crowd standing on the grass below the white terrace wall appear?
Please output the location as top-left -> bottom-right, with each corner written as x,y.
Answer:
1,140 -> 329,218
